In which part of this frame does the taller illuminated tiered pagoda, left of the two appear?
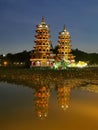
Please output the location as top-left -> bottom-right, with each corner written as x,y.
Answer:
30,17 -> 54,67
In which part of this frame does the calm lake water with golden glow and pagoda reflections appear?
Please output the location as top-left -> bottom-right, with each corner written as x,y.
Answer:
0,82 -> 98,130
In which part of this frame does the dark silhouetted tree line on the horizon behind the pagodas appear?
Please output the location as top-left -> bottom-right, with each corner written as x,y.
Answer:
0,46 -> 98,67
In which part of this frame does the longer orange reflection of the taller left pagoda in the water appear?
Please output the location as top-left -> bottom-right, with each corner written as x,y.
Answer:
34,86 -> 50,118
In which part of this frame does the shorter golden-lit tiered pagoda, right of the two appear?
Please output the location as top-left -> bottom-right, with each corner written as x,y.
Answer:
57,25 -> 74,61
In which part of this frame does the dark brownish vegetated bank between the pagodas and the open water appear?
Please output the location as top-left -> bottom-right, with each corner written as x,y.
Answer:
0,67 -> 98,88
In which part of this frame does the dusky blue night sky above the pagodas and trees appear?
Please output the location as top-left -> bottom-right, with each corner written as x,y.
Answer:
0,0 -> 98,54
